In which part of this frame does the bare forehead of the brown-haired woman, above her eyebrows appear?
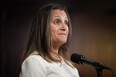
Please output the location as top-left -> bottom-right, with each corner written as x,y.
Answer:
51,9 -> 67,18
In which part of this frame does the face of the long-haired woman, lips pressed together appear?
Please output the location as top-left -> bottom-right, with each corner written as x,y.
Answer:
50,10 -> 69,46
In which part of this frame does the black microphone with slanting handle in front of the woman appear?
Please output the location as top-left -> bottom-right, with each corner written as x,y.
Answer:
70,53 -> 111,70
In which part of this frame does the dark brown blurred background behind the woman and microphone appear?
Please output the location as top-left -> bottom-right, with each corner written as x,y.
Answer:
0,0 -> 116,77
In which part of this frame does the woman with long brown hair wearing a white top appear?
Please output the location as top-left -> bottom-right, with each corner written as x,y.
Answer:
19,4 -> 79,77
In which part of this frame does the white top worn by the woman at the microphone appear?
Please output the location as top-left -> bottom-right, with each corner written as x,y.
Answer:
19,55 -> 79,77
